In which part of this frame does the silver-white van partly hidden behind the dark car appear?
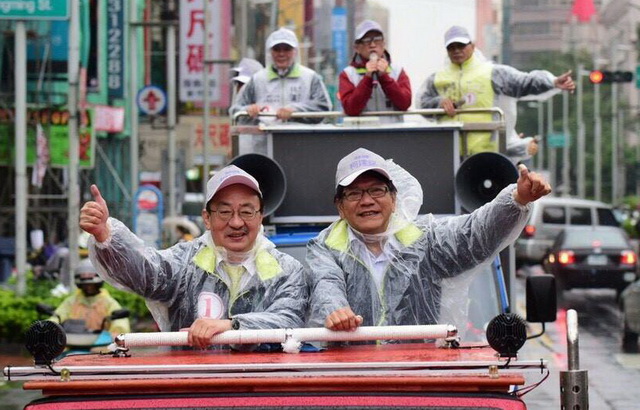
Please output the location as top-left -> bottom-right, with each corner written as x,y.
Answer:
516,197 -> 620,263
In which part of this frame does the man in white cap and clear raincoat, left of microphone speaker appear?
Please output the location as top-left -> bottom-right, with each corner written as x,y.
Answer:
230,27 -> 331,123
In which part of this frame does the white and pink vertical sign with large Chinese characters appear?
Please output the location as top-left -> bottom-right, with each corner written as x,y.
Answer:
179,0 -> 231,107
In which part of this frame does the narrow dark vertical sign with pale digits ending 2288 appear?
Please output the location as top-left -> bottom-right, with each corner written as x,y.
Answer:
107,0 -> 125,98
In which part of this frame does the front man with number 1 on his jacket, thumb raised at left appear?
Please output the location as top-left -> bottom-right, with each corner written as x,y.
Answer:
80,165 -> 308,348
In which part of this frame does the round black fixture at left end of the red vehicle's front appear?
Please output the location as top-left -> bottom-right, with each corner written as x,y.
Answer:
25,320 -> 67,365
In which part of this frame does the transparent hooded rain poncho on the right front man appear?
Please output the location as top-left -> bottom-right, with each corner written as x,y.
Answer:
307,159 -> 530,342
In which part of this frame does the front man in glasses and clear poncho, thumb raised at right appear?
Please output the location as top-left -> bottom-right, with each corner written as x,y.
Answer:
307,148 -> 551,330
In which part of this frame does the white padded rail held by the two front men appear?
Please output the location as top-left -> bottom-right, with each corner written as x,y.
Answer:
115,325 -> 458,352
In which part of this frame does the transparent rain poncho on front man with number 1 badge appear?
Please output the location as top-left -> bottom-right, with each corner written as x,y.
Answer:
89,218 -> 308,342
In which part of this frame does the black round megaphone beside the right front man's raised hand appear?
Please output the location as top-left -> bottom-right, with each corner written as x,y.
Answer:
455,152 -> 518,212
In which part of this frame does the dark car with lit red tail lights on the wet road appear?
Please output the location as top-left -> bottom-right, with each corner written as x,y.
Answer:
543,226 -> 638,300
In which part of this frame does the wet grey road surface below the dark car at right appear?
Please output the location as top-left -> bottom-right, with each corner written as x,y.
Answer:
518,267 -> 640,410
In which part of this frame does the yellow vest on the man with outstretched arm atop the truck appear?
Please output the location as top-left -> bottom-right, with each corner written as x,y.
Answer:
434,56 -> 498,155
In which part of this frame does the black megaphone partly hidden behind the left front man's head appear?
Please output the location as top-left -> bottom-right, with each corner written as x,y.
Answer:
230,154 -> 287,216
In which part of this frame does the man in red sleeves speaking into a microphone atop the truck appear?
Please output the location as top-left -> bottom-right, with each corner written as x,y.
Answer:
339,20 -> 411,121
